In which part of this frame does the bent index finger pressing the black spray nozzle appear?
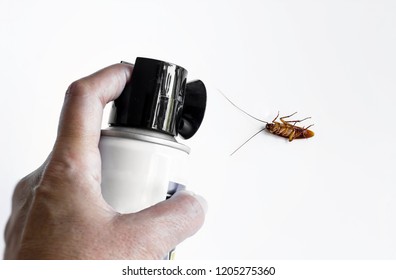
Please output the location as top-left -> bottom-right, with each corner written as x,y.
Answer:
57,63 -> 133,149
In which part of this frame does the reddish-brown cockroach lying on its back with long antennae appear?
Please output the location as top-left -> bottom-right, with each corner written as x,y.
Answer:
219,91 -> 314,156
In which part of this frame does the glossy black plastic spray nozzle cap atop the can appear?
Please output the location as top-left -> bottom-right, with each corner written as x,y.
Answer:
109,57 -> 206,139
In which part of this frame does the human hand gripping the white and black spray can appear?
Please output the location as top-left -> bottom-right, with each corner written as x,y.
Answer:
4,64 -> 207,259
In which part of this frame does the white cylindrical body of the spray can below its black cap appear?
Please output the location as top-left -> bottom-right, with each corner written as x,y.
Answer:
99,136 -> 188,213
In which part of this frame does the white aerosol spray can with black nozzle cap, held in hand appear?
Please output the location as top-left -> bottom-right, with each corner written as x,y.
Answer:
99,57 -> 206,258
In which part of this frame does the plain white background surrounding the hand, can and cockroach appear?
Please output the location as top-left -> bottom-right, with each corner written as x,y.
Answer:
0,0 -> 396,259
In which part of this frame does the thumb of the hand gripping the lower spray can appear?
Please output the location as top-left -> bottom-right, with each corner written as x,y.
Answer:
114,190 -> 207,259
